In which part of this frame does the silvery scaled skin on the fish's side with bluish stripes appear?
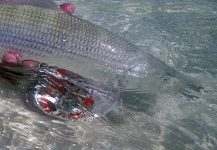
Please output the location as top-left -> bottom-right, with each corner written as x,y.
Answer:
0,5 -> 164,74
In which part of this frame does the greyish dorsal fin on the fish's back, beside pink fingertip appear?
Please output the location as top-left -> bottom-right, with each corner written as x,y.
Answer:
0,0 -> 61,11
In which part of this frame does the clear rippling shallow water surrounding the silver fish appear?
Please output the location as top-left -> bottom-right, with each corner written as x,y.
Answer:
0,0 -> 217,150
